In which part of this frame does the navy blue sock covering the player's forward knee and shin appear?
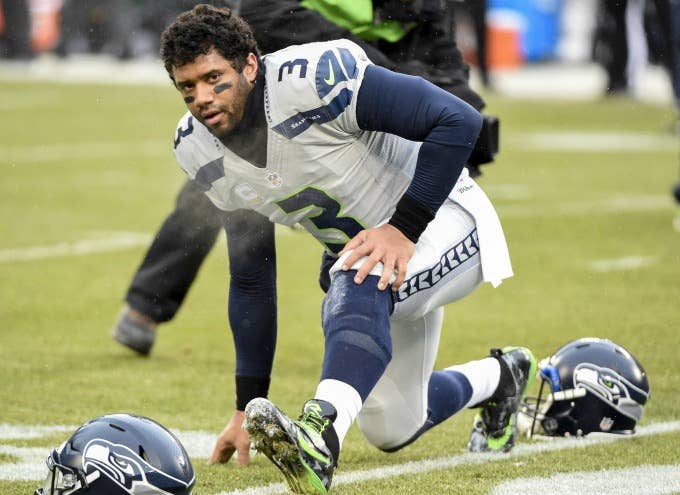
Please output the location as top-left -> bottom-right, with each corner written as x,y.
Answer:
321,270 -> 393,401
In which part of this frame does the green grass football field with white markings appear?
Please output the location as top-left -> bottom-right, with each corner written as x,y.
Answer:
0,78 -> 680,495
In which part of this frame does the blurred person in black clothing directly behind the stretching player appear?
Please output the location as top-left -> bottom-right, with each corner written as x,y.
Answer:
113,0 -> 498,355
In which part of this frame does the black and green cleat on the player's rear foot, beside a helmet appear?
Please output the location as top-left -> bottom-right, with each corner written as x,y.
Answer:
468,347 -> 536,452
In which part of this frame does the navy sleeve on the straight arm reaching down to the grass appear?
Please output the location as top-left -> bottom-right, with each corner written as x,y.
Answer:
222,210 -> 277,384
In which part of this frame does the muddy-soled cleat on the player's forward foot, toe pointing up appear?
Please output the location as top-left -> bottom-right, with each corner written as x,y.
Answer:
243,398 -> 340,495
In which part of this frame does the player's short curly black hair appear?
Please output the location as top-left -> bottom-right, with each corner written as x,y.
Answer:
161,4 -> 259,81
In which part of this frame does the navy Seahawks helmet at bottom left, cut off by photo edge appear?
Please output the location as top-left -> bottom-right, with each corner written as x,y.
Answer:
35,414 -> 196,495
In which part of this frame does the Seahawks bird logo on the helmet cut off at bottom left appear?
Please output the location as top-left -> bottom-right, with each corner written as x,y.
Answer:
83,438 -> 193,495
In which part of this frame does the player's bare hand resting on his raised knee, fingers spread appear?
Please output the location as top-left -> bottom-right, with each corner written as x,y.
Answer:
339,224 -> 415,291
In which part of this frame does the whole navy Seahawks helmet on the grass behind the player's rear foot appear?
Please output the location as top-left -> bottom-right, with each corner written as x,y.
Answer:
518,338 -> 649,436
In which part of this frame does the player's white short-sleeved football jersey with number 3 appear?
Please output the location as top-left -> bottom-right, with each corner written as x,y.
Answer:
175,40 -> 420,252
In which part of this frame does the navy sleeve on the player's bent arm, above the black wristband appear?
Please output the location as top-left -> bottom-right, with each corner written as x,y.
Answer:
357,65 -> 482,213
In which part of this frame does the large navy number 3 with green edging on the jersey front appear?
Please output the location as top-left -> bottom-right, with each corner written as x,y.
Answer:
276,186 -> 365,253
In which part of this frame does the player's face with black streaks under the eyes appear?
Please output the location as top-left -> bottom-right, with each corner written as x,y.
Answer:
172,49 -> 257,138
